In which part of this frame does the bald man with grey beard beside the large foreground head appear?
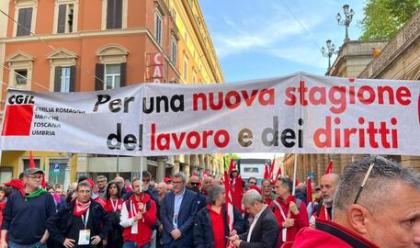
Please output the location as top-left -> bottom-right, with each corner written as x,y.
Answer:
315,173 -> 340,220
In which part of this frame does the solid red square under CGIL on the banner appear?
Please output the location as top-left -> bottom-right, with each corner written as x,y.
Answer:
2,104 -> 34,136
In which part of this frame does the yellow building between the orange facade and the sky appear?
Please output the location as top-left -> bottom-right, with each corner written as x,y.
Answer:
165,0 -> 224,179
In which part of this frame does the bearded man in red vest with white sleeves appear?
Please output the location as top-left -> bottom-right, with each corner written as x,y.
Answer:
120,179 -> 157,248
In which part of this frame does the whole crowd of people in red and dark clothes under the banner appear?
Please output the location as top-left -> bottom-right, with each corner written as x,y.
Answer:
0,157 -> 420,248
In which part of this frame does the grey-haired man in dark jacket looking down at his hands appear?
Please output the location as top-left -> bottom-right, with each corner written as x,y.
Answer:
229,189 -> 279,248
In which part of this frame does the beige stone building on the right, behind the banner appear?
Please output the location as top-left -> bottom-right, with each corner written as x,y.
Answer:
284,11 -> 420,182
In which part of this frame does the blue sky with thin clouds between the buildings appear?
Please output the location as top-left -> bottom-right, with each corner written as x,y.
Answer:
200,0 -> 365,83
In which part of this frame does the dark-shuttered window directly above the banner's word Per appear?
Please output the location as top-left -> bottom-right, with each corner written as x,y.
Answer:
95,63 -> 126,90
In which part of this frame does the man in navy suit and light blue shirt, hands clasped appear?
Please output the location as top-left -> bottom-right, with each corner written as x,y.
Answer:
160,173 -> 198,248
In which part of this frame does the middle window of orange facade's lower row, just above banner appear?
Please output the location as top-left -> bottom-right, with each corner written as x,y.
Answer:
54,66 -> 76,93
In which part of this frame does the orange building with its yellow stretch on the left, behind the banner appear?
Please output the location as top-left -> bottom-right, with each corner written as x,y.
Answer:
0,0 -> 224,184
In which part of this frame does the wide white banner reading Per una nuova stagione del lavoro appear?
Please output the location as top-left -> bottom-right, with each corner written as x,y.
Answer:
1,73 -> 420,156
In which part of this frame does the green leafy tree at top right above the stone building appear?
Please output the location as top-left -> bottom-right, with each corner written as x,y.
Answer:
360,0 -> 420,40
